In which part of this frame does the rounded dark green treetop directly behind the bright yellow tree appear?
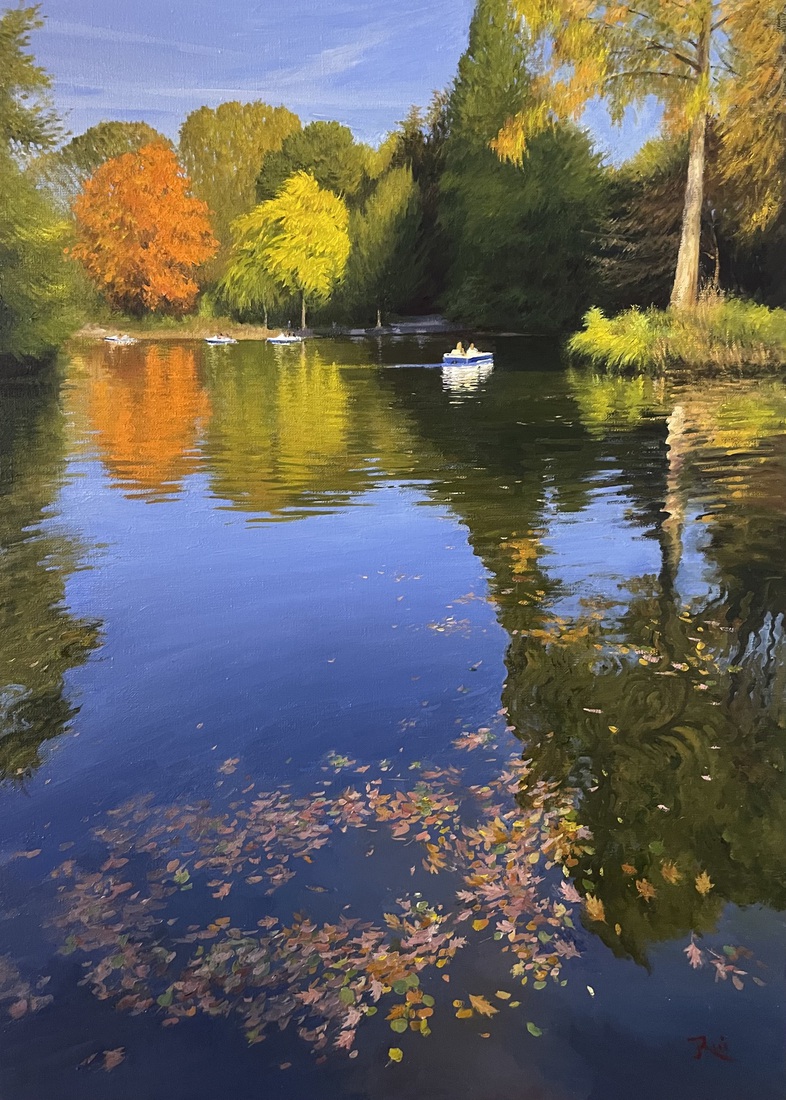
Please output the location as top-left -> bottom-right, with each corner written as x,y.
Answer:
256,122 -> 373,202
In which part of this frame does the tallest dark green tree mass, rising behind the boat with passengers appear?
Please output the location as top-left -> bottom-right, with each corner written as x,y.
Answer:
440,0 -> 605,330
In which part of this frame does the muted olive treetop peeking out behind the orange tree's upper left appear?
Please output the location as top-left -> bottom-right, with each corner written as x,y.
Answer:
31,122 -> 170,210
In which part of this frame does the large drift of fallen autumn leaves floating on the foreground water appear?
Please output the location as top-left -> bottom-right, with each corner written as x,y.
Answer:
53,739 -> 586,1060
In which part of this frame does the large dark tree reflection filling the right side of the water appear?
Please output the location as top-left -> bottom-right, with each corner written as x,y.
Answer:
391,374 -> 786,961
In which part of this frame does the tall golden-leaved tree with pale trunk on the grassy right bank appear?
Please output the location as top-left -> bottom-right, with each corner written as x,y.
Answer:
495,0 -> 776,309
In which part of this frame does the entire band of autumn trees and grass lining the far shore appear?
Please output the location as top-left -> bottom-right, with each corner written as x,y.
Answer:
0,0 -> 786,371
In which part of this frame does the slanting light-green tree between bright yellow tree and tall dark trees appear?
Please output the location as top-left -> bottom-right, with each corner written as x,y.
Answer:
342,168 -> 421,325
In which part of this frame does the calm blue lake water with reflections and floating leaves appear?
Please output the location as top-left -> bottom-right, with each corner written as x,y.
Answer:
0,340 -> 786,1100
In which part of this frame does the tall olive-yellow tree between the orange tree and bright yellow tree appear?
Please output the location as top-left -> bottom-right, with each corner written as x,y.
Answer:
179,101 -> 300,244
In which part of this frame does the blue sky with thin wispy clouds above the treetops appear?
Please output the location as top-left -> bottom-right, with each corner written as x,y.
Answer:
33,0 -> 655,160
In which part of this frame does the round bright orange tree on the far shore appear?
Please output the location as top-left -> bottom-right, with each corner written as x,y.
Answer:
71,143 -> 219,314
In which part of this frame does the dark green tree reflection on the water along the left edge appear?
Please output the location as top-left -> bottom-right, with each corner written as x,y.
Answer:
0,386 -> 99,779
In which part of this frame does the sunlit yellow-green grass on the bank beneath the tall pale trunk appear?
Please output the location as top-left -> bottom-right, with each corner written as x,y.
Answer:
567,290 -> 786,374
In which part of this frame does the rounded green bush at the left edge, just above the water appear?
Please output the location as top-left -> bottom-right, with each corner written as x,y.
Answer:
0,151 -> 77,370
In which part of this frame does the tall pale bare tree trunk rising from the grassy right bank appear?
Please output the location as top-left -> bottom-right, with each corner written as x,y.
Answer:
669,4 -> 712,309
